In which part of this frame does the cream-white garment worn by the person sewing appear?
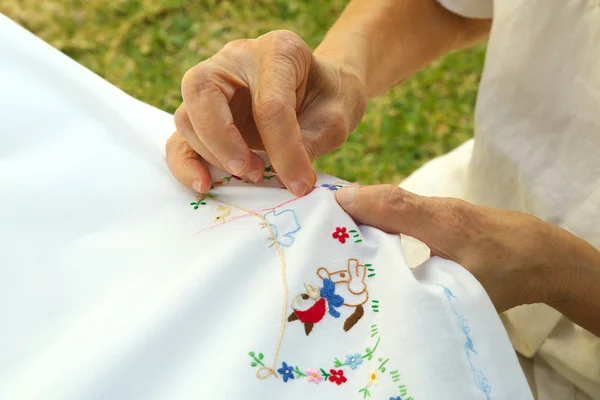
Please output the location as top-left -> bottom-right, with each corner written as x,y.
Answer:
402,0 -> 600,400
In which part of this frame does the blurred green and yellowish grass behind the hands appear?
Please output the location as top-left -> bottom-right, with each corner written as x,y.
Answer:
0,0 -> 485,184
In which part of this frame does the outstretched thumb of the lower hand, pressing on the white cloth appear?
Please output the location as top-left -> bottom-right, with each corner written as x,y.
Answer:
336,185 -> 448,247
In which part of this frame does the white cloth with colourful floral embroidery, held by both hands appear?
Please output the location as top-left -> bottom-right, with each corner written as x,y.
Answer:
0,16 -> 532,400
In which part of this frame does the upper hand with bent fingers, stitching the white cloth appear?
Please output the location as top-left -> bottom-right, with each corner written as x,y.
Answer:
167,31 -> 366,196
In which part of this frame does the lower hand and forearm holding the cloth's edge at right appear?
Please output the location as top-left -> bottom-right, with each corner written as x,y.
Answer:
337,185 -> 600,334
